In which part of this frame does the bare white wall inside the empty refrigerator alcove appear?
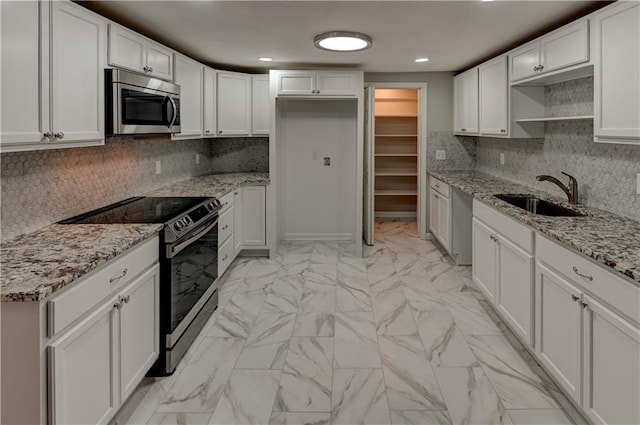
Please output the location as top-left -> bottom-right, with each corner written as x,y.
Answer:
276,99 -> 360,240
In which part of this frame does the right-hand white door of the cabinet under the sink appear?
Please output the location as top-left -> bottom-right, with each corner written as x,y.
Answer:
497,236 -> 534,347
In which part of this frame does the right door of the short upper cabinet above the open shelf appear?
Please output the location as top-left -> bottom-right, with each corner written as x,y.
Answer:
540,19 -> 589,72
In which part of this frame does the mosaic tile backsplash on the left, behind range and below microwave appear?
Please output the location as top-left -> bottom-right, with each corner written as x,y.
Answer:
0,137 -> 269,240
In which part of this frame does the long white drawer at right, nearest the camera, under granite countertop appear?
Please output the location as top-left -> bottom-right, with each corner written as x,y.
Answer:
536,235 -> 640,324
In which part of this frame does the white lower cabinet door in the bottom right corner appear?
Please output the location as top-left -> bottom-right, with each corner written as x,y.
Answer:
583,296 -> 640,424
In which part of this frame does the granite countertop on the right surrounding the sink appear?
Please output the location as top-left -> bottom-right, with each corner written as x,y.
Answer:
429,171 -> 640,286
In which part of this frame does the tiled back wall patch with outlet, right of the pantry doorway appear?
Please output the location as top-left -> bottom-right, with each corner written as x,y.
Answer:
427,131 -> 477,170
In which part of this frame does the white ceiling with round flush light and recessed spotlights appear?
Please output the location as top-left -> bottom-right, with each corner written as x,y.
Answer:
80,0 -> 608,72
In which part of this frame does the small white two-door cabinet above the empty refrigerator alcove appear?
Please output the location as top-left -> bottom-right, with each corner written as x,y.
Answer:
277,71 -> 359,97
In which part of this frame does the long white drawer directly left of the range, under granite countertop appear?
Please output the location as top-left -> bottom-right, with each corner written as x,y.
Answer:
47,236 -> 159,337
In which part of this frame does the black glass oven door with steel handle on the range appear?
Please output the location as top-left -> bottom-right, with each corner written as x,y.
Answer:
161,216 -> 218,348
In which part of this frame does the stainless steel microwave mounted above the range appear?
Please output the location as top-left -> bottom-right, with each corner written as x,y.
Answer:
104,69 -> 180,136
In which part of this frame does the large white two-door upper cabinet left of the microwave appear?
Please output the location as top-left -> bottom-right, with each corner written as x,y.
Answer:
0,1 -> 107,151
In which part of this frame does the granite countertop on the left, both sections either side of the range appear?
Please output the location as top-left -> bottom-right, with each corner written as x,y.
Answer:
0,173 -> 269,302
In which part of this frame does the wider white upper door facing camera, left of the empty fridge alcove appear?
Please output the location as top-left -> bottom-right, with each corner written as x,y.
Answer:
218,72 -> 251,136
